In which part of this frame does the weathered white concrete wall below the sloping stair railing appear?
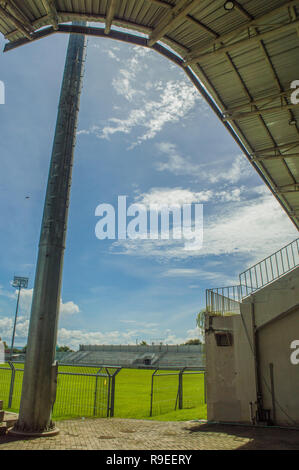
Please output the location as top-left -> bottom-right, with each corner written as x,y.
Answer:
206,268 -> 299,426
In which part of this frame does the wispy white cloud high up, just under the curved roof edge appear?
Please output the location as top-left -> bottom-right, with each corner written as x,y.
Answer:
77,47 -> 207,148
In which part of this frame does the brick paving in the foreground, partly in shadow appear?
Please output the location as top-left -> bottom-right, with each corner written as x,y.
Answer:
0,418 -> 299,450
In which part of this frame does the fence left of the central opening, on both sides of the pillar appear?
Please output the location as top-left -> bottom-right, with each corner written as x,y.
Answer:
0,362 -> 121,418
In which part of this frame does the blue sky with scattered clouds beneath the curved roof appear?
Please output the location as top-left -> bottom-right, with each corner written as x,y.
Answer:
0,25 -> 297,348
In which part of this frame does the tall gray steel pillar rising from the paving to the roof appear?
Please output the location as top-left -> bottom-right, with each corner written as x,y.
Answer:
12,22 -> 86,434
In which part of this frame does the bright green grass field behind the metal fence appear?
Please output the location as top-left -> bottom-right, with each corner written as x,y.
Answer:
0,364 -> 206,421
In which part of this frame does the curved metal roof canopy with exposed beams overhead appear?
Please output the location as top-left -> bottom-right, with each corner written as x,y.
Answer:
0,0 -> 299,228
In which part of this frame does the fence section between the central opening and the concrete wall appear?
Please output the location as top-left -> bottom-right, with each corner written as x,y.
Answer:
150,368 -> 206,416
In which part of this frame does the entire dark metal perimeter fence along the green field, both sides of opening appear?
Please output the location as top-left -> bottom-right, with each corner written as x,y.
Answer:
0,362 -> 206,419
